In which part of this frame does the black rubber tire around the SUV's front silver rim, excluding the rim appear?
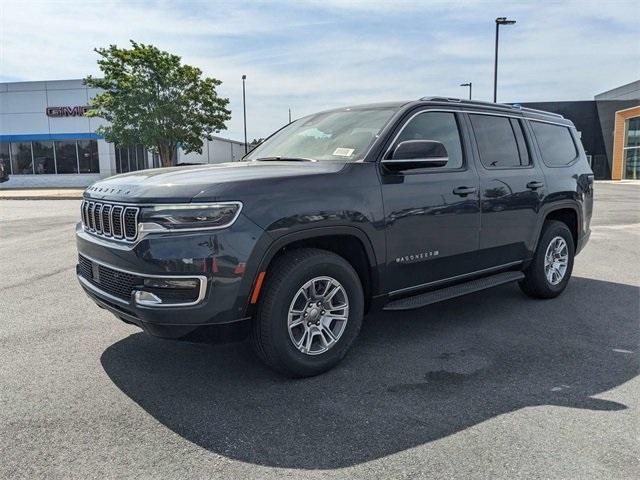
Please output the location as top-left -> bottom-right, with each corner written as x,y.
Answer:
251,248 -> 364,378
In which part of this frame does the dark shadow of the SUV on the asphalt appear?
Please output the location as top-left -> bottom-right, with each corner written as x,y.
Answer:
101,278 -> 639,469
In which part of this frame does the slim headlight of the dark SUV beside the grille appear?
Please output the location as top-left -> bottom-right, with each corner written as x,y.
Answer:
140,202 -> 242,230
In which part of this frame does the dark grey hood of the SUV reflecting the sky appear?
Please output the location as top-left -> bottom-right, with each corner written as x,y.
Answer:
84,161 -> 345,203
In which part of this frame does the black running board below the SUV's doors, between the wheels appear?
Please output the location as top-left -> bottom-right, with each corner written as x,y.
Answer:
384,272 -> 524,310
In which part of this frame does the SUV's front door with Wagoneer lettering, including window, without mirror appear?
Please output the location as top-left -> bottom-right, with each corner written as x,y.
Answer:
381,110 -> 480,293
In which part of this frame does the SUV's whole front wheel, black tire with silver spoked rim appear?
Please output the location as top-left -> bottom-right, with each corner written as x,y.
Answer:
251,248 -> 364,377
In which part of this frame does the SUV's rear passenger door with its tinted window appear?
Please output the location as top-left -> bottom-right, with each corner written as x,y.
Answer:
467,112 -> 545,268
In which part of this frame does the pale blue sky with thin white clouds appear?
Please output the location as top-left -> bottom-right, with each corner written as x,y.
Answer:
0,0 -> 640,140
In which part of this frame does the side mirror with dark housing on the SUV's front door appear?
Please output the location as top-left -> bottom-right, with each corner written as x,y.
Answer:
382,140 -> 449,171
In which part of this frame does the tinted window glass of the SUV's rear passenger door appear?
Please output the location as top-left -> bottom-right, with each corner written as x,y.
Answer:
469,114 -> 529,168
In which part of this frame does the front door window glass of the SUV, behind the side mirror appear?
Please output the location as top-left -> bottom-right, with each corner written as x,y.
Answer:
394,112 -> 462,170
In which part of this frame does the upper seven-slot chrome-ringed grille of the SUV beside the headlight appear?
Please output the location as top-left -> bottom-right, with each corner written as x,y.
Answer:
80,200 -> 140,242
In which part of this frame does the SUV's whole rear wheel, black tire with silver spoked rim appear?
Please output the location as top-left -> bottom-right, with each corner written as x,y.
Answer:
520,220 -> 575,298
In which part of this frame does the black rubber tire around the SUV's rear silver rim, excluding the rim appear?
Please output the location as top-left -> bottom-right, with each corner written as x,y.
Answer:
519,220 -> 575,298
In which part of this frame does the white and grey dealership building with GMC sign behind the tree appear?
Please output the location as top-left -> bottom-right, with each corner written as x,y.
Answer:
0,80 -> 244,188
